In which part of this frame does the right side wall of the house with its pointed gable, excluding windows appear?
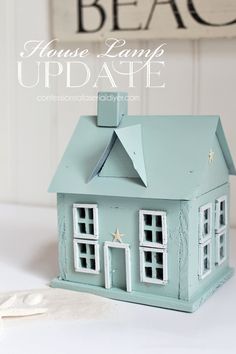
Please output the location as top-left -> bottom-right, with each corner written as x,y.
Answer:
188,136 -> 230,298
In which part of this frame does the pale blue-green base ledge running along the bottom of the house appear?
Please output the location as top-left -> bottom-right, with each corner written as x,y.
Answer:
51,267 -> 234,312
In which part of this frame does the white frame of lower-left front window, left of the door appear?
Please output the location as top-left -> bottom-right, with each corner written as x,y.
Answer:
74,239 -> 100,274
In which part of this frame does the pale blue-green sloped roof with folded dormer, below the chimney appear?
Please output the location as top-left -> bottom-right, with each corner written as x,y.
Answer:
49,116 -> 236,200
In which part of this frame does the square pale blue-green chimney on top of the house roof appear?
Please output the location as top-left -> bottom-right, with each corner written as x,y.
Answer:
97,92 -> 128,127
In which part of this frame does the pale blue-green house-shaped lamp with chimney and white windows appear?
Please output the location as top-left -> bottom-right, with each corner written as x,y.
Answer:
50,92 -> 236,312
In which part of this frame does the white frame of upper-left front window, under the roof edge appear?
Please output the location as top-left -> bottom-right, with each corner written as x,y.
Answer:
73,204 -> 99,240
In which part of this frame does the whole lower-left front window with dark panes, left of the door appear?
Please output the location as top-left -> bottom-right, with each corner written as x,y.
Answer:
74,239 -> 99,273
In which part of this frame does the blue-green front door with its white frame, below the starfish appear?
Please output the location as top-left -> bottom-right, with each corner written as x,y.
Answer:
104,241 -> 131,292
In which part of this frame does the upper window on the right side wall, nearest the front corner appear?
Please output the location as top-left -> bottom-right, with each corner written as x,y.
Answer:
200,204 -> 212,243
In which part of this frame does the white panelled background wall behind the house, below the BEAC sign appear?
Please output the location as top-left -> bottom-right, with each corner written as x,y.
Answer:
0,0 -> 236,226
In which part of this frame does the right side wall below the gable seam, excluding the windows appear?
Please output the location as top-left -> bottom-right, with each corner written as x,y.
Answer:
188,183 -> 229,298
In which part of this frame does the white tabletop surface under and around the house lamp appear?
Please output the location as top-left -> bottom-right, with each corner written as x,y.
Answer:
0,205 -> 236,354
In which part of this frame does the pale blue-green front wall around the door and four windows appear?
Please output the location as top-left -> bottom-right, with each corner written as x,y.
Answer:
58,194 -> 188,298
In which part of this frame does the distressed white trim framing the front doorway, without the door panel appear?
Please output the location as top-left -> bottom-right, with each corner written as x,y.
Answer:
104,241 -> 132,292
